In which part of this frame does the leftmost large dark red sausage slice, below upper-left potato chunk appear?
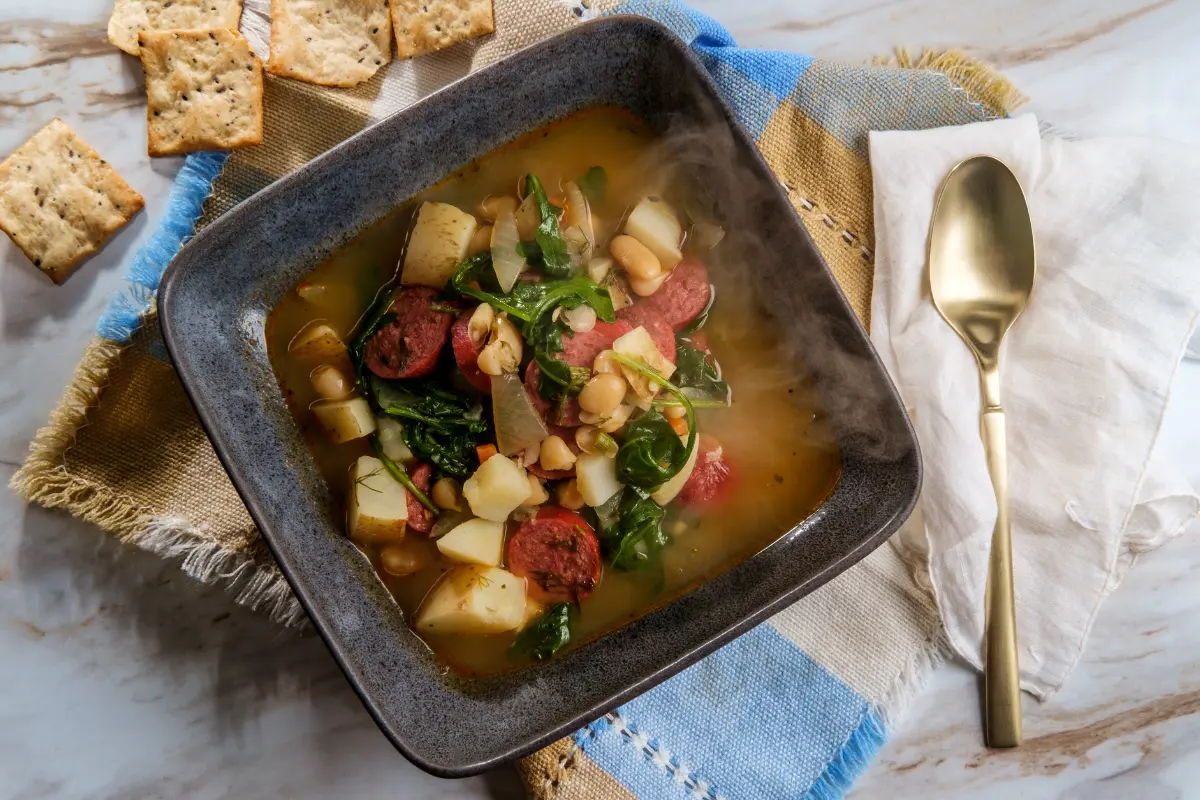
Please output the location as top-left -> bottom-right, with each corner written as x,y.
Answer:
366,287 -> 455,378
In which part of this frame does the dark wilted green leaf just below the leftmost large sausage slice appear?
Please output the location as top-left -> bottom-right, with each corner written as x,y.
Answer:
370,375 -> 491,477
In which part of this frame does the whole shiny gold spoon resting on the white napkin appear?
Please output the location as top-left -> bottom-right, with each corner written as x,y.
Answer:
929,156 -> 1034,747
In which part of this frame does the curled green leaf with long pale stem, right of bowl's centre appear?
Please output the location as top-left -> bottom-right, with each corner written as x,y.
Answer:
612,353 -> 696,493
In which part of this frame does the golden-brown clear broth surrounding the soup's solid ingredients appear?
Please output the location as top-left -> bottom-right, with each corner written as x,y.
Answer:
266,109 -> 839,675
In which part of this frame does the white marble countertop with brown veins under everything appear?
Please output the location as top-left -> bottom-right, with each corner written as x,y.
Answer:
0,0 -> 1200,800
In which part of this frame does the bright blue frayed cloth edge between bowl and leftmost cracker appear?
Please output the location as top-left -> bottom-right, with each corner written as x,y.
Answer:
96,151 -> 229,344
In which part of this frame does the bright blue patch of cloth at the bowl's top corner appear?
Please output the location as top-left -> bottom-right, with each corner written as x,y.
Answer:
617,0 -> 812,139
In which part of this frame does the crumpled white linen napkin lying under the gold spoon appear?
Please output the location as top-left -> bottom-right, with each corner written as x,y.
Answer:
870,115 -> 1200,698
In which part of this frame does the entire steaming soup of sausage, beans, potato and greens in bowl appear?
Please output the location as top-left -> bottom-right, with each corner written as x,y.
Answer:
266,109 -> 839,676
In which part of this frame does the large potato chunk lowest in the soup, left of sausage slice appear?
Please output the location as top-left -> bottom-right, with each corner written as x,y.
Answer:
416,564 -> 526,633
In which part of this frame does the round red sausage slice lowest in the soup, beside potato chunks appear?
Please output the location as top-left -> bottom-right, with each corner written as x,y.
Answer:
506,506 -> 600,602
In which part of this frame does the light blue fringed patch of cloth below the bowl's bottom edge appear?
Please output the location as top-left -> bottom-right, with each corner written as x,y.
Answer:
576,625 -> 884,800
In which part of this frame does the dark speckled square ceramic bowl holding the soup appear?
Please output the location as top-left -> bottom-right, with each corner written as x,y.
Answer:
160,17 -> 920,776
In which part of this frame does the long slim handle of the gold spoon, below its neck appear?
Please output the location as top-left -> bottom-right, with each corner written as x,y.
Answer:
982,403 -> 1021,747
